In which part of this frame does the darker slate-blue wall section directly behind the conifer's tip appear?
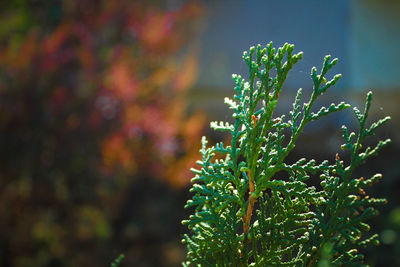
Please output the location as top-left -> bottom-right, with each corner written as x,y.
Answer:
197,0 -> 350,90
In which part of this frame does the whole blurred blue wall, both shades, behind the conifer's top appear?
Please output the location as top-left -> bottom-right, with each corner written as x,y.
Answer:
195,0 -> 400,93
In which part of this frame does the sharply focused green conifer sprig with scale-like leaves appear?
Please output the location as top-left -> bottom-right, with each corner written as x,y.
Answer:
182,43 -> 390,266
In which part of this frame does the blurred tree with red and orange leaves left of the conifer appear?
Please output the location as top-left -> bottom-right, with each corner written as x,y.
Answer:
0,0 -> 203,266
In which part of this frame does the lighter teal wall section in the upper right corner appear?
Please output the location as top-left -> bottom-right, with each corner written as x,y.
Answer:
349,0 -> 400,90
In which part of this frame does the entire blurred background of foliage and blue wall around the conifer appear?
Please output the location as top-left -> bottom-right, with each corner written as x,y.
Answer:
0,0 -> 400,267
